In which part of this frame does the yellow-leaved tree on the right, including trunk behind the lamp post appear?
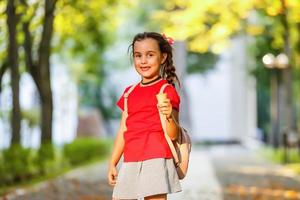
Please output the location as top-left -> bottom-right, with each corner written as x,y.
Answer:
156,0 -> 300,144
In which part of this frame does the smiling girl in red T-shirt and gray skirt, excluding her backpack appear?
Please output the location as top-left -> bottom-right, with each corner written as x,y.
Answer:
108,32 -> 181,200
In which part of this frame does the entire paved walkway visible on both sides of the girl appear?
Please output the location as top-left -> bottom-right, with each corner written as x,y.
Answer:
0,146 -> 300,200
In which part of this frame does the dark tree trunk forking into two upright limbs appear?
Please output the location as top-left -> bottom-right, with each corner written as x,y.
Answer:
21,0 -> 57,144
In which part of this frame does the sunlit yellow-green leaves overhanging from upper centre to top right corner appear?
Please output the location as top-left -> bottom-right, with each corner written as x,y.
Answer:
156,0 -> 300,56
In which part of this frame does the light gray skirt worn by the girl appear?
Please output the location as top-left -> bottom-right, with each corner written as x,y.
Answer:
112,158 -> 181,200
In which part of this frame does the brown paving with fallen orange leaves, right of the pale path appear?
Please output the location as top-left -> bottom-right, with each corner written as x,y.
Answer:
210,146 -> 300,200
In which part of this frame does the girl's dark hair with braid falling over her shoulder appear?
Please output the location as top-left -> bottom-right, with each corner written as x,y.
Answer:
128,32 -> 180,86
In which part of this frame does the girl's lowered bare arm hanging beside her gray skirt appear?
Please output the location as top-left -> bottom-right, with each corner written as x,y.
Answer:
107,112 -> 126,186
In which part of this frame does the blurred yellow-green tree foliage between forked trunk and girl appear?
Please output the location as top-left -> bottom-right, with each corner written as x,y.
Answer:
54,0 -> 122,117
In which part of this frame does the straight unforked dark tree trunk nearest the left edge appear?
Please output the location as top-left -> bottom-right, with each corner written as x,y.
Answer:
6,0 -> 21,143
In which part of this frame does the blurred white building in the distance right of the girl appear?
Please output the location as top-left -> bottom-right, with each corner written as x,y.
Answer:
179,37 -> 257,144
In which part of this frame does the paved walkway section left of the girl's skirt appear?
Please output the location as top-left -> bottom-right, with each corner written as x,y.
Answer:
0,163 -> 112,200
